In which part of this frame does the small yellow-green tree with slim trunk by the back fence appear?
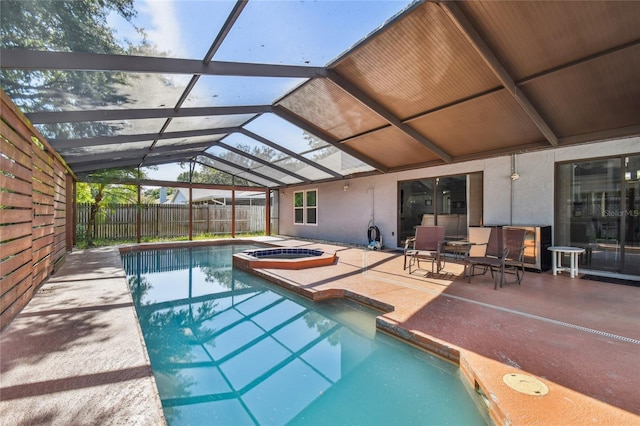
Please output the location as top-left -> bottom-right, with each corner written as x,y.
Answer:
76,169 -> 146,247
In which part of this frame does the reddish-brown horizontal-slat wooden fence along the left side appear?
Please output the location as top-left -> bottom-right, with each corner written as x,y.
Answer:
0,91 -> 71,329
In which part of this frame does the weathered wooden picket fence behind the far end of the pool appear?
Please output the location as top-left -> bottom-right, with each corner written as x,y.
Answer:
77,204 -> 265,240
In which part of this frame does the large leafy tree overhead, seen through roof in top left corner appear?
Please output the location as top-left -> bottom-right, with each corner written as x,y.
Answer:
0,0 -> 145,139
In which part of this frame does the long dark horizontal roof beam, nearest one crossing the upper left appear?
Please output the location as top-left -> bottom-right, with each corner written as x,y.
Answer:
0,49 -> 326,78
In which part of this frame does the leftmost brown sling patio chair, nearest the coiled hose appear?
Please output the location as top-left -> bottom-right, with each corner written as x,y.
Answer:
404,226 -> 445,274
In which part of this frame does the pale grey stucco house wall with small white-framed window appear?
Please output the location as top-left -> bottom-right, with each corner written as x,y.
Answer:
278,137 -> 640,248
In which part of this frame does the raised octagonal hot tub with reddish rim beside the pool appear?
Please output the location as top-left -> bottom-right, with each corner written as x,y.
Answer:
233,247 -> 336,269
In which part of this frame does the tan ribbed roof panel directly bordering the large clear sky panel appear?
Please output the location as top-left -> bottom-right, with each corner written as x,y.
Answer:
335,3 -> 500,119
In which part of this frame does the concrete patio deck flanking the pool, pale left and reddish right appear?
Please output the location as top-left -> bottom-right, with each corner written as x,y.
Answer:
0,238 -> 640,425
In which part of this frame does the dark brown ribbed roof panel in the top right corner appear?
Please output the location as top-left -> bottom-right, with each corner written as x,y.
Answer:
459,1 -> 640,80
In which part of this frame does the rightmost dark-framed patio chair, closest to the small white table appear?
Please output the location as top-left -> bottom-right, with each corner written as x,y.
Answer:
465,227 -> 526,290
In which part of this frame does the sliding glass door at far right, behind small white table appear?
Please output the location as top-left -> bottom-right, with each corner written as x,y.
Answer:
555,155 -> 640,275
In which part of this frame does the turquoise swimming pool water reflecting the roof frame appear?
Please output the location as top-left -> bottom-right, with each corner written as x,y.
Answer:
122,245 -> 487,426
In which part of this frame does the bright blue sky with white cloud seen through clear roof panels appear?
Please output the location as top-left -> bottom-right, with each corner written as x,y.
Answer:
108,0 -> 412,180
